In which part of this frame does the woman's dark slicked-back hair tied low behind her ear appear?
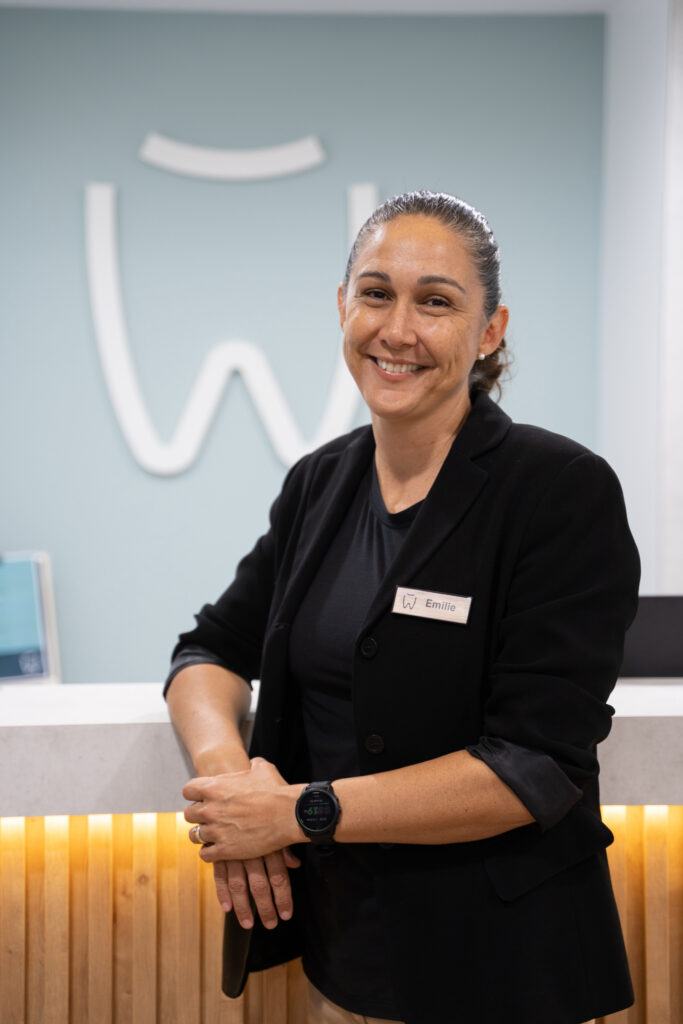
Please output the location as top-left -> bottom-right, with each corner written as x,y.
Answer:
343,189 -> 510,395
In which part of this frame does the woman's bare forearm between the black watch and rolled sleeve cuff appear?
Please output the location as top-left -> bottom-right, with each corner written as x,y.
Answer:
334,751 -> 533,844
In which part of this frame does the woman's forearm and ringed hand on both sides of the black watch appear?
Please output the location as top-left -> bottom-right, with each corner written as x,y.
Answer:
183,751 -> 533,860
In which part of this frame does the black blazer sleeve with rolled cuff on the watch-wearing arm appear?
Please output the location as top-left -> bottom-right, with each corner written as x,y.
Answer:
468,452 -> 640,828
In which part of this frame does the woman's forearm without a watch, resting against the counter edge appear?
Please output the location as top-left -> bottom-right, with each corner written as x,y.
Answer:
166,665 -> 251,775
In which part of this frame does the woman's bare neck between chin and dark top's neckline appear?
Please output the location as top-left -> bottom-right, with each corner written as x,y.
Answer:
373,398 -> 472,512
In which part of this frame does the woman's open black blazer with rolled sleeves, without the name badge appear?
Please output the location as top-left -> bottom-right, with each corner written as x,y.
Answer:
176,393 -> 639,1024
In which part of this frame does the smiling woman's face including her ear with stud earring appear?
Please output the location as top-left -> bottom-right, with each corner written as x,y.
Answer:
338,215 -> 508,429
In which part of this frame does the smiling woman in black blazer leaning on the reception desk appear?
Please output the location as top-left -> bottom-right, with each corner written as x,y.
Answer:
168,193 -> 638,1024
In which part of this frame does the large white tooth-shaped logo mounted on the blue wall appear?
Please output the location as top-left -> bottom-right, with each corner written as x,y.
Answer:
85,133 -> 378,476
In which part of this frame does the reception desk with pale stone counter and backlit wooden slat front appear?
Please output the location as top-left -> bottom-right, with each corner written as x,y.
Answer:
0,680 -> 683,1024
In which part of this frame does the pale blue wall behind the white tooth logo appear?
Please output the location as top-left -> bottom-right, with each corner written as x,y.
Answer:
0,9 -> 604,682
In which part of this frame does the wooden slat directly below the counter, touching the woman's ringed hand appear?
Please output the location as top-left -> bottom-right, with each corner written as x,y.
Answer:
176,814 -> 202,1024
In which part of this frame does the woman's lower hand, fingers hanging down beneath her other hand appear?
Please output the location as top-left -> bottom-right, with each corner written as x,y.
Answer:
213,847 -> 301,929
